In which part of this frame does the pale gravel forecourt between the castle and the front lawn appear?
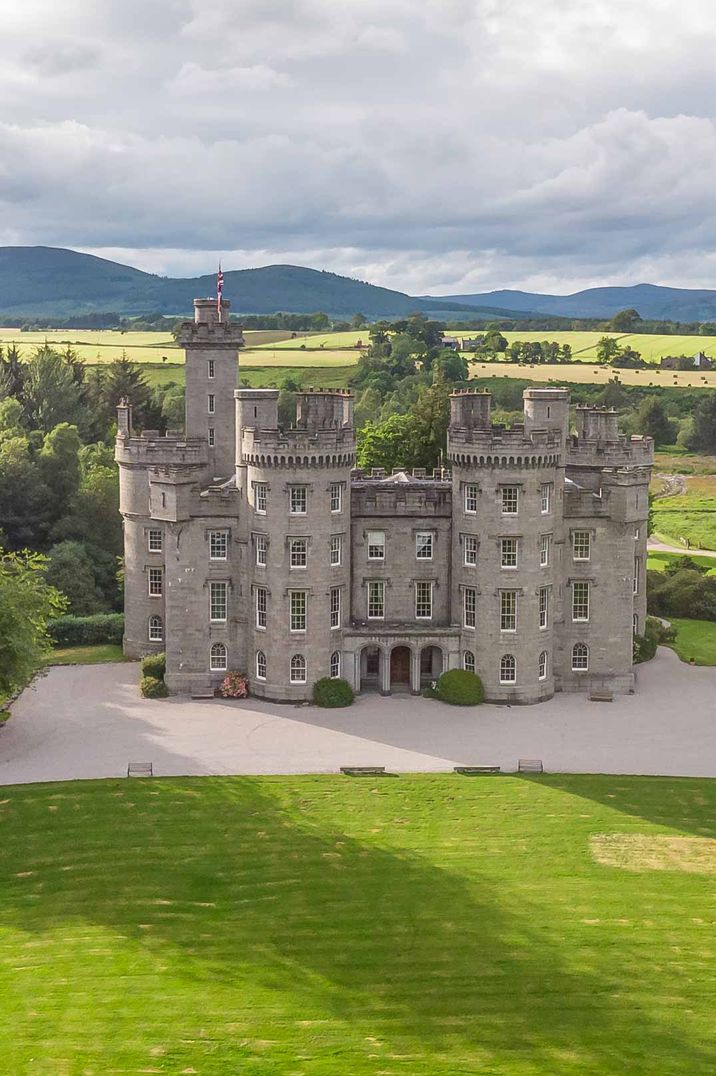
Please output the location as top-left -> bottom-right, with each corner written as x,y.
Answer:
0,648 -> 716,784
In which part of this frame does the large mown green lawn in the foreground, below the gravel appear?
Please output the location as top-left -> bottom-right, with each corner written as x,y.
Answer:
0,775 -> 716,1076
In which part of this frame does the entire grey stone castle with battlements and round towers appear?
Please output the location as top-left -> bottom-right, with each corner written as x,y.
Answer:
116,299 -> 654,703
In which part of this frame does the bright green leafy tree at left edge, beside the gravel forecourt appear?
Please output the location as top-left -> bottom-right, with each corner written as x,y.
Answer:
0,551 -> 67,697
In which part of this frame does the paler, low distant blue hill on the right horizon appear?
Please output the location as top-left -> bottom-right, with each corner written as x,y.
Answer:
423,284 -> 716,322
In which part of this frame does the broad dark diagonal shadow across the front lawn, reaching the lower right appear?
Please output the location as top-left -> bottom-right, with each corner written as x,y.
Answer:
0,778 -> 713,1076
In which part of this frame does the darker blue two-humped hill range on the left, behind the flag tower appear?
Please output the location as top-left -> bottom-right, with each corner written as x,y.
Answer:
0,246 -> 516,318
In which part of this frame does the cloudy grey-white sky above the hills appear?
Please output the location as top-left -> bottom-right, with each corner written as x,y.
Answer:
0,0 -> 716,294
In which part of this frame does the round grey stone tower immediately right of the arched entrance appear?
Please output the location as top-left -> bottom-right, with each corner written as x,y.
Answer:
448,390 -> 568,703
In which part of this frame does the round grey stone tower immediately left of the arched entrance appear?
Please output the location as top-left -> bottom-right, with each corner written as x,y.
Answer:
235,388 -> 355,699
